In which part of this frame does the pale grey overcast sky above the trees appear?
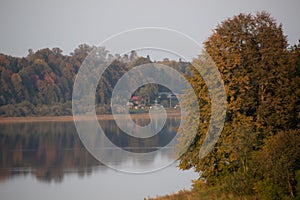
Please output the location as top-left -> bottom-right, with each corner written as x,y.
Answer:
0,0 -> 300,60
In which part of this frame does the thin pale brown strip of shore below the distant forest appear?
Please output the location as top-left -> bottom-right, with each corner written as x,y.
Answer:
0,111 -> 181,124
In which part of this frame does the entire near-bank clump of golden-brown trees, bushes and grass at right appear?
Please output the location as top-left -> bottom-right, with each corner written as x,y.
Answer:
177,12 -> 300,199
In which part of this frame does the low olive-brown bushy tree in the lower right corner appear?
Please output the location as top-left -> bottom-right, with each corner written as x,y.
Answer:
255,130 -> 300,199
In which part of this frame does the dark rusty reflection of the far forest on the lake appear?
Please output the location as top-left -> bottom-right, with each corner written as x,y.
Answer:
0,118 -> 180,182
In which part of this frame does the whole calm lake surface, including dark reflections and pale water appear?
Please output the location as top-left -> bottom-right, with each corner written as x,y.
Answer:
0,118 -> 197,200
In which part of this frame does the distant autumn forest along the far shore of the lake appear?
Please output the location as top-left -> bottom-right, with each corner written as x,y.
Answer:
0,44 -> 188,116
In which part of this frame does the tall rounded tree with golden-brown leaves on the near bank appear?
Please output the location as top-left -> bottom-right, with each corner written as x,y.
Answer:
180,12 -> 299,193
